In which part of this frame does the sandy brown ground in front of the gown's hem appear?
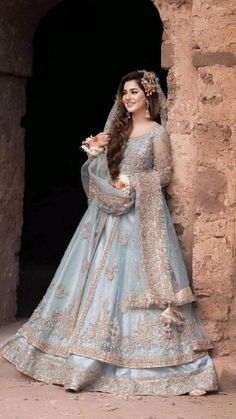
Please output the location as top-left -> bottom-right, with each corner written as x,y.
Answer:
0,321 -> 236,419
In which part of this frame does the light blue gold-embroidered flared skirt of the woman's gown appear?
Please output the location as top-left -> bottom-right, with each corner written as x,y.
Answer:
0,200 -> 217,395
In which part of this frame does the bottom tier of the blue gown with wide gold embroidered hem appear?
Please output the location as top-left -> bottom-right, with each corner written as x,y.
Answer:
0,337 -> 217,396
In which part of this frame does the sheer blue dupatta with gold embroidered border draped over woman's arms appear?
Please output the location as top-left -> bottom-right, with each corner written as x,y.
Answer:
82,78 -> 204,328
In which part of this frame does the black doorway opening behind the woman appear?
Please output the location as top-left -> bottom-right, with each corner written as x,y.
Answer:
17,0 -> 166,317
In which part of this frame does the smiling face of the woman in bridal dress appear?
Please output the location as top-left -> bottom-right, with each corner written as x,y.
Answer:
122,80 -> 147,113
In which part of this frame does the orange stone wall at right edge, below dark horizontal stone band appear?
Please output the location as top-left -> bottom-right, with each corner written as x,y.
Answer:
193,65 -> 236,355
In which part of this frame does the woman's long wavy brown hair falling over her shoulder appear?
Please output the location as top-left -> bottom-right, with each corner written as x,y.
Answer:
107,70 -> 160,180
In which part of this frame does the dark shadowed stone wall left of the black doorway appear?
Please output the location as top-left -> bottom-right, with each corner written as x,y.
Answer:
0,0 -> 59,324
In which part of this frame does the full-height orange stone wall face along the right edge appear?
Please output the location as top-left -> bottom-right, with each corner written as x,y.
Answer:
193,0 -> 236,356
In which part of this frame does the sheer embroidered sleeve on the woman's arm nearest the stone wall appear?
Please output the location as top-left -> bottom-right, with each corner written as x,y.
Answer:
153,128 -> 172,188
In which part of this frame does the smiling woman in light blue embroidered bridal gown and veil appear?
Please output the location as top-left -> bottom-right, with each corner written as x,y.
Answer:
1,70 -> 217,395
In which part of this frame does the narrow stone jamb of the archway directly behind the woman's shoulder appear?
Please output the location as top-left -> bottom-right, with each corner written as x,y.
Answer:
155,0 -> 198,277
